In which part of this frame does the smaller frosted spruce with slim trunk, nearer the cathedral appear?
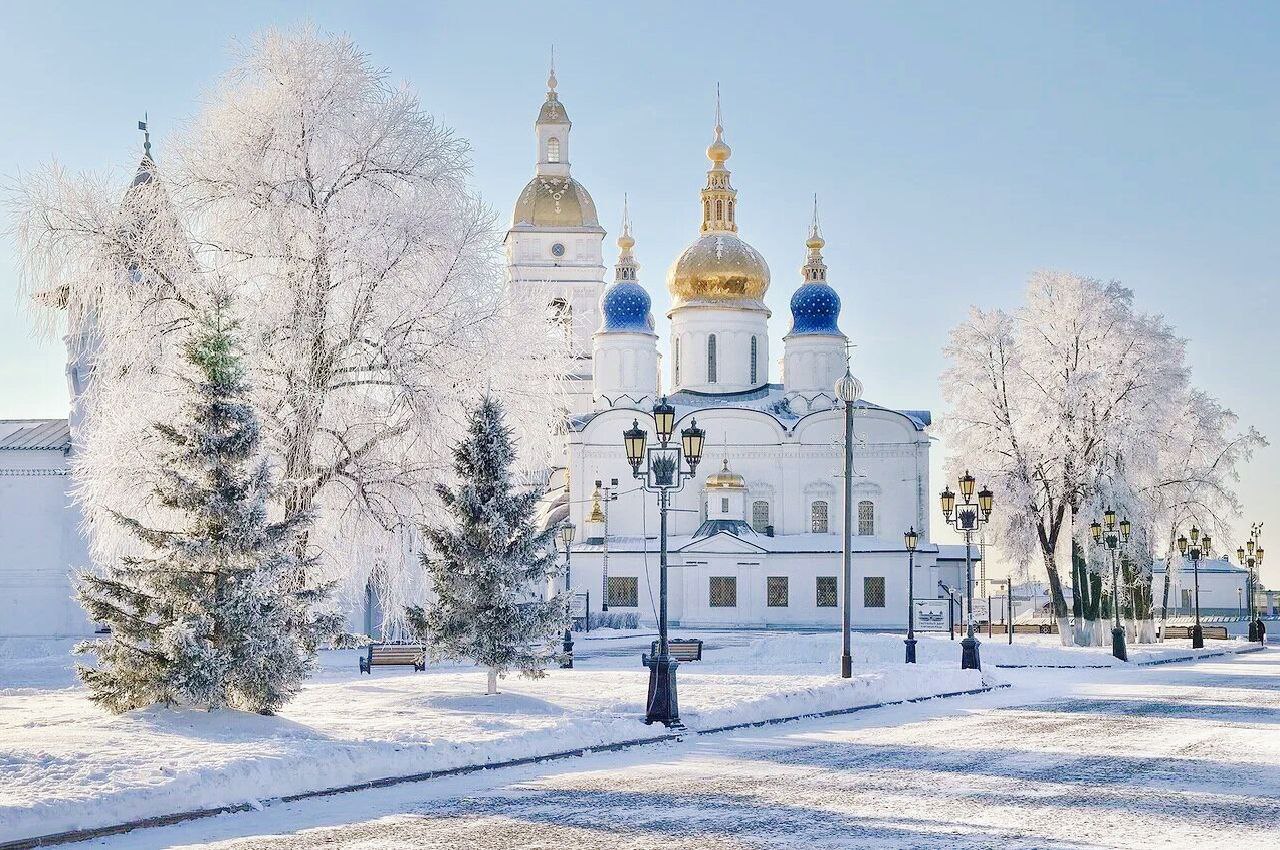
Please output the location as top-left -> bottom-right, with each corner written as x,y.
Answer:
407,394 -> 568,694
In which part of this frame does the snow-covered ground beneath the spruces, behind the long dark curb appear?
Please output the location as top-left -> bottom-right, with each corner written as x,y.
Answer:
0,630 -> 1259,841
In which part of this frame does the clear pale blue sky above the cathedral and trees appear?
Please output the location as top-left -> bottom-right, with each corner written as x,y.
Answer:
0,0 -> 1280,586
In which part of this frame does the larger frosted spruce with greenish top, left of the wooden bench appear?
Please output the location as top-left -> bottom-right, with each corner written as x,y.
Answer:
77,300 -> 342,713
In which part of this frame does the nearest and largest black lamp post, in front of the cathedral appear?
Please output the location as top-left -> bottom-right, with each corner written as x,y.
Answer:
622,396 -> 707,726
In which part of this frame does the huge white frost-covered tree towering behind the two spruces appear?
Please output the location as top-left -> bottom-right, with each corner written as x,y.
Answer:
15,29 -> 567,624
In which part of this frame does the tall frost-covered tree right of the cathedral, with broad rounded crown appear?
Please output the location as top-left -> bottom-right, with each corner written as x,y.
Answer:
942,271 -> 1218,643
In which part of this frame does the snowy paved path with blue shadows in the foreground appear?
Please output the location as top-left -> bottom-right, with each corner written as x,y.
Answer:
72,652 -> 1280,850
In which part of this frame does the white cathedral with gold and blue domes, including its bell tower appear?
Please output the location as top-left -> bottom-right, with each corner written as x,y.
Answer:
506,72 -> 977,627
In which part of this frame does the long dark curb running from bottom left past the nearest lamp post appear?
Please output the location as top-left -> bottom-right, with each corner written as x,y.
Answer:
0,684 -> 1011,850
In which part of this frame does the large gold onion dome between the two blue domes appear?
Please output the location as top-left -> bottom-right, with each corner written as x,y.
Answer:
667,233 -> 769,307
